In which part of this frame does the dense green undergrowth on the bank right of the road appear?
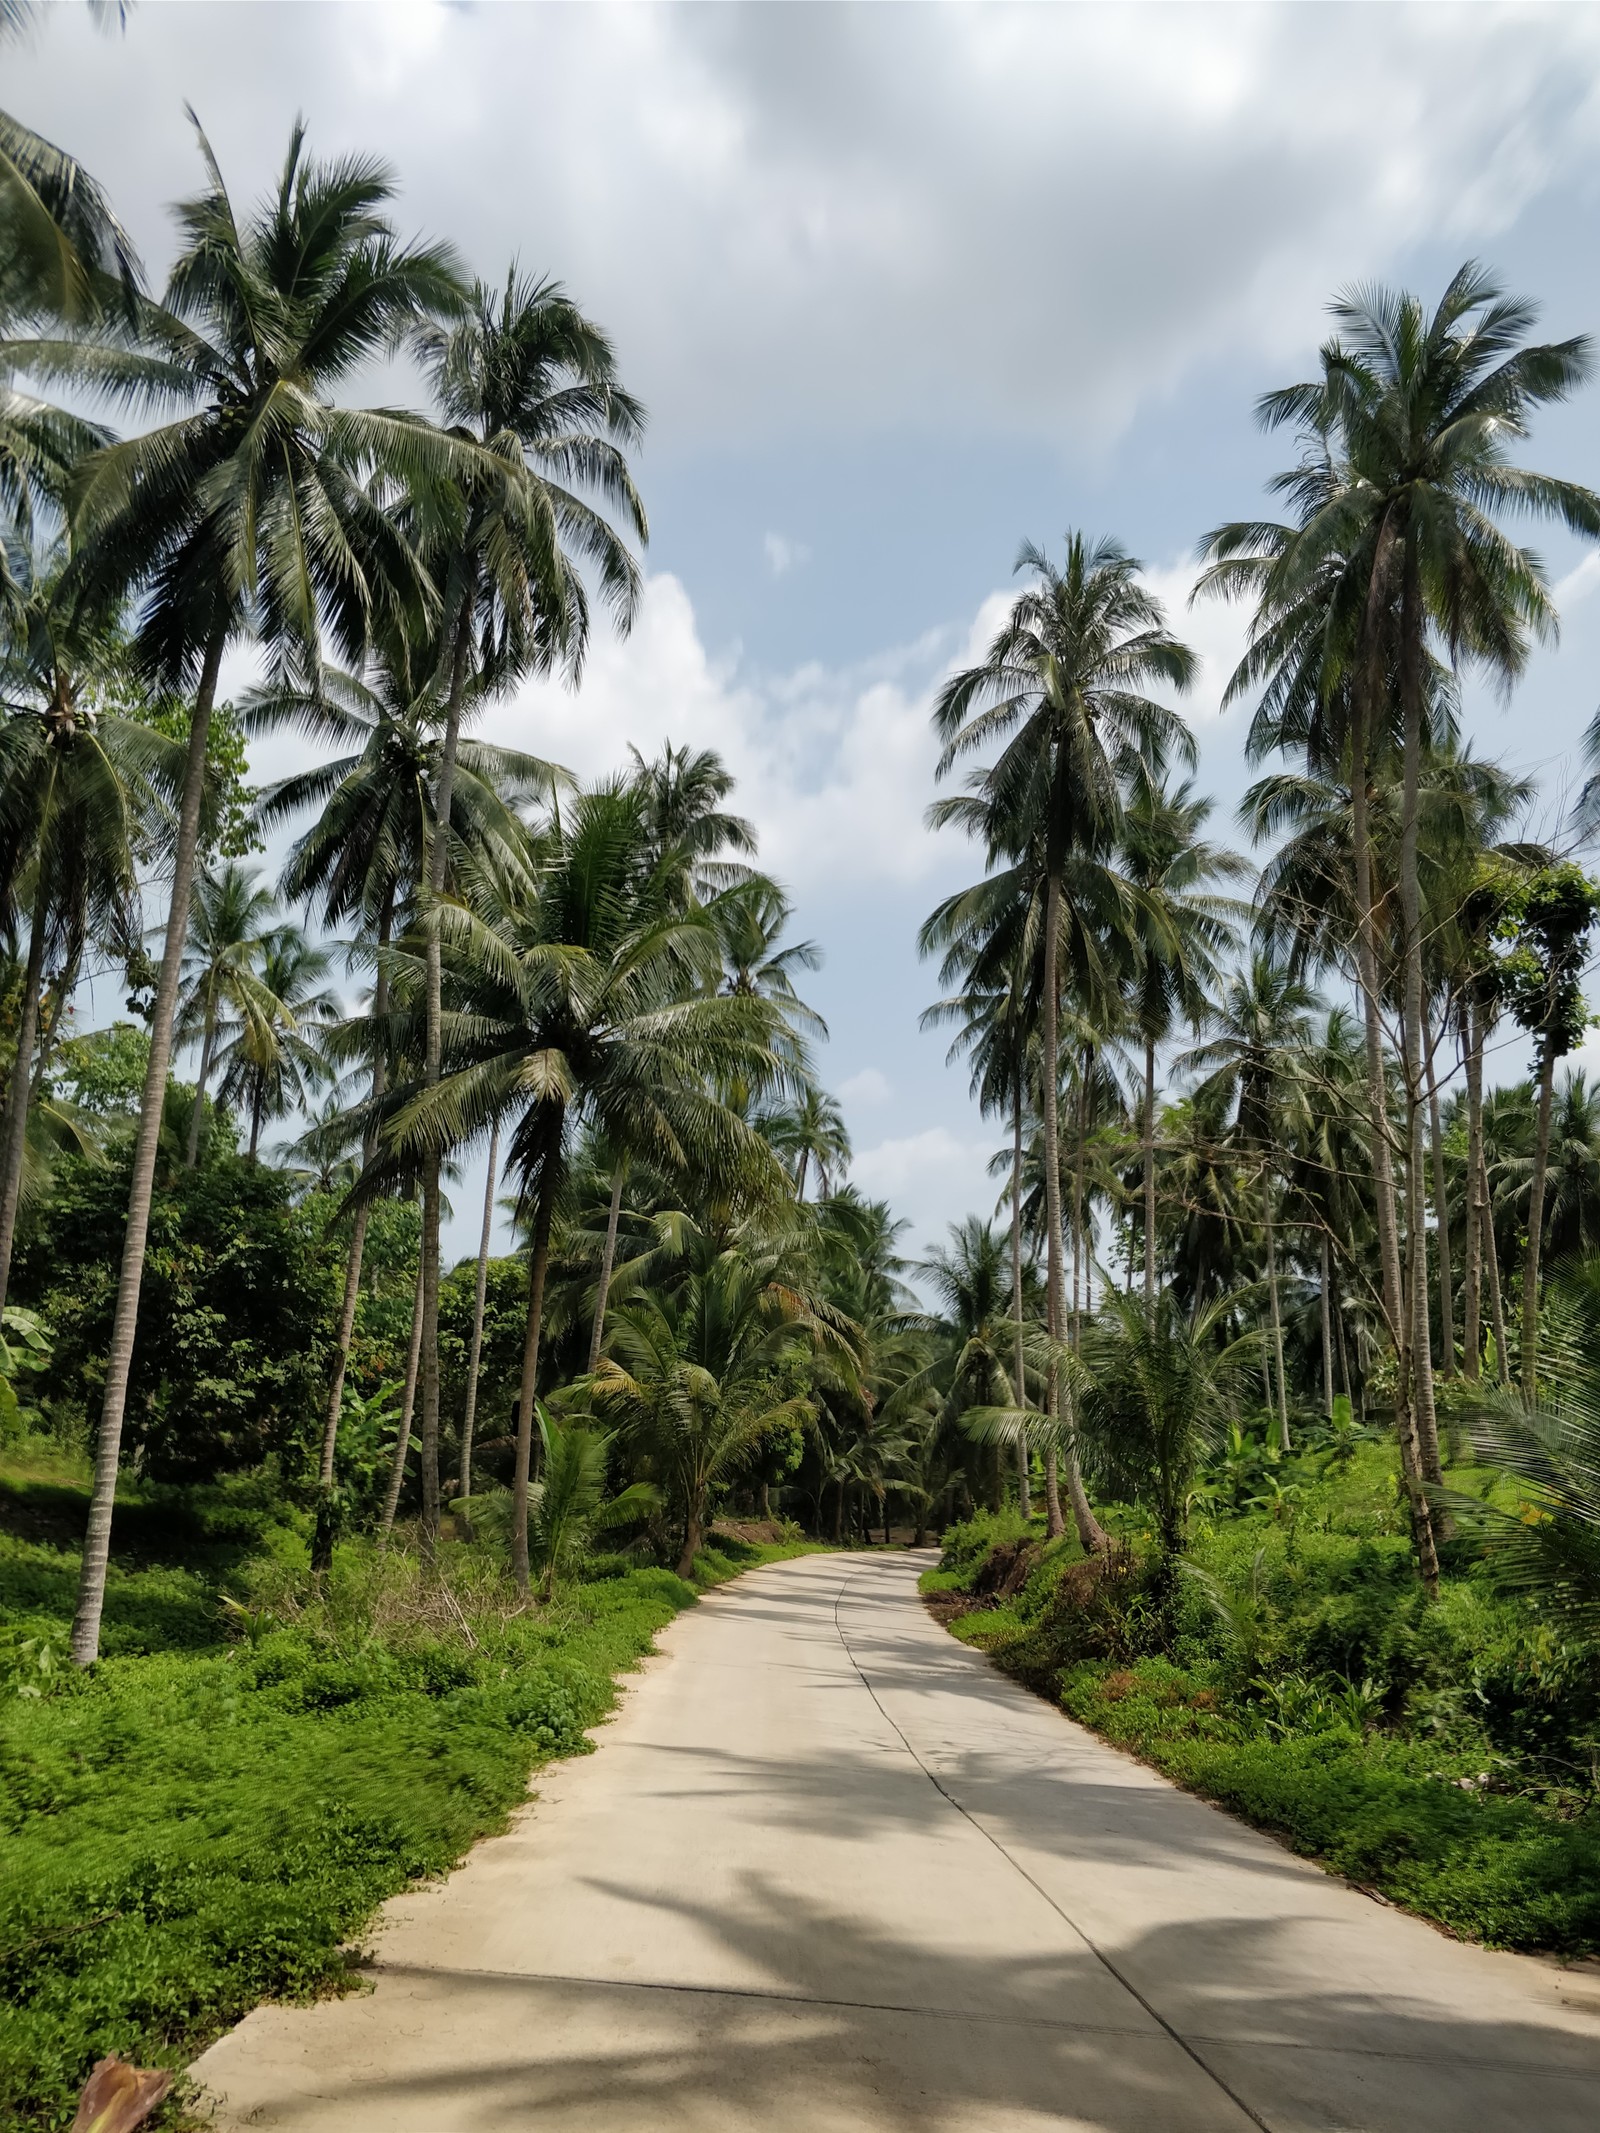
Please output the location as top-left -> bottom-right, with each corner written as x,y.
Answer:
922,1438 -> 1600,1956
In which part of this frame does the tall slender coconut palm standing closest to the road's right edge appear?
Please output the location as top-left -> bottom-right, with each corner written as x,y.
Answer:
934,533 -> 1195,1549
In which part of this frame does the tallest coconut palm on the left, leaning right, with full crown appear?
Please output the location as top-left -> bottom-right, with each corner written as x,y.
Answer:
28,128 -> 461,1666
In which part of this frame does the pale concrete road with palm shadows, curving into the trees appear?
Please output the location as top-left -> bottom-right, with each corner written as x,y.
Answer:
196,1555 -> 1600,2133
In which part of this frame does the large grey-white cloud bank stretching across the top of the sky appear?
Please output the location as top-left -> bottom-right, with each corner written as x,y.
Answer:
6,0 -> 1600,448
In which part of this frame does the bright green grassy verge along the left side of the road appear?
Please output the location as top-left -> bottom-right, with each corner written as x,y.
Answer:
0,1472 -> 806,2133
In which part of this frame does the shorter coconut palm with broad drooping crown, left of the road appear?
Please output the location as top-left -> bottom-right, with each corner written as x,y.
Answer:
393,785 -> 781,1589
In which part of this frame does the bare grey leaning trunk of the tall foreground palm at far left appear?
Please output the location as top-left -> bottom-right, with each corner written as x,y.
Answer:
73,629 -> 226,1666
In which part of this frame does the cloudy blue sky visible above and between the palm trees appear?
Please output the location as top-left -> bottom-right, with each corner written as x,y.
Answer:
15,0 -> 1600,1252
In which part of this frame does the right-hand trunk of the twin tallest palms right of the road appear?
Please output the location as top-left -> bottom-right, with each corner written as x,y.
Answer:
1399,535 -> 1442,1485
